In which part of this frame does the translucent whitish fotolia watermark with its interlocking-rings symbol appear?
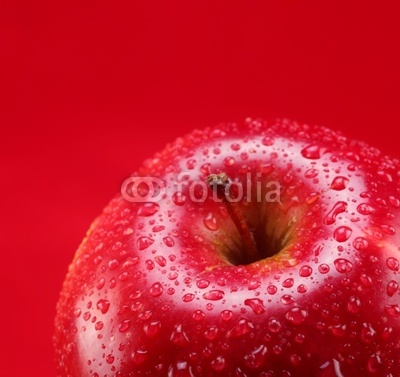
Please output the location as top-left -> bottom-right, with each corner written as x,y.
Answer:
121,172 -> 281,203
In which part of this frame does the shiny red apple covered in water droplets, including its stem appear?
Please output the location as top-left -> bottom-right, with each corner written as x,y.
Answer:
54,120 -> 400,377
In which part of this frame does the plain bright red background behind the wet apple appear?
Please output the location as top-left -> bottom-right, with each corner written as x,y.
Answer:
0,0 -> 400,377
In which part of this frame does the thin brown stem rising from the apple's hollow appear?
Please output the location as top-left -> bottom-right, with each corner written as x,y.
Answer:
207,173 -> 258,263
